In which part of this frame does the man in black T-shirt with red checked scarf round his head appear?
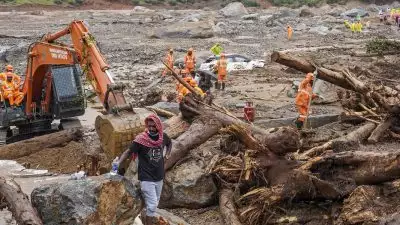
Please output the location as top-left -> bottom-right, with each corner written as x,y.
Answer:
119,115 -> 172,225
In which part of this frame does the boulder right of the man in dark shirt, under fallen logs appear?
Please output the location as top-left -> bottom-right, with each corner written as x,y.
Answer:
160,159 -> 218,208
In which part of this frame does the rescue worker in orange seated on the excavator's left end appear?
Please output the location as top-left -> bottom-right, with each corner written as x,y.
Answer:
2,72 -> 24,108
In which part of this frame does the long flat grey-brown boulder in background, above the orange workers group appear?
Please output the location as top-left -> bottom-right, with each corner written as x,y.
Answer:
150,21 -> 214,39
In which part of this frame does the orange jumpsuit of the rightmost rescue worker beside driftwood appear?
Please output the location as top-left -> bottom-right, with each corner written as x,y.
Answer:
296,74 -> 317,122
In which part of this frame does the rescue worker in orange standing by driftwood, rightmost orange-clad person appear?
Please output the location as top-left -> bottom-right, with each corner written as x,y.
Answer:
295,73 -> 318,129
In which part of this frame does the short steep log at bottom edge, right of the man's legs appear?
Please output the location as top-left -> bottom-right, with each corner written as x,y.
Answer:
219,188 -> 242,225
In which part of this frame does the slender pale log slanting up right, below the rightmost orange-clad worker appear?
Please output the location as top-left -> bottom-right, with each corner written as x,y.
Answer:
296,122 -> 376,160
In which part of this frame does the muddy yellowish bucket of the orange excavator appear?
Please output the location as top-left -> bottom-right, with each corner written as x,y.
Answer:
95,108 -> 154,159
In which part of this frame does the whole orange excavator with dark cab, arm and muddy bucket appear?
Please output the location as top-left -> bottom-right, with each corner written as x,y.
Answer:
0,20 -> 151,157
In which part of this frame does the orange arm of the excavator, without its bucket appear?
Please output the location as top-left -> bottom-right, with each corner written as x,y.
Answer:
42,20 -> 130,112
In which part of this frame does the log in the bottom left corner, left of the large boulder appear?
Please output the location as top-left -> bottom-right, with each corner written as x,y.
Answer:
0,177 -> 43,225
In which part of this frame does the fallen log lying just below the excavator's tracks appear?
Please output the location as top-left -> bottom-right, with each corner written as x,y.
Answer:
0,129 -> 83,159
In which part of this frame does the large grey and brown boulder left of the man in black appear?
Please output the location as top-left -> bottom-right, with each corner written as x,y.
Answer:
31,175 -> 143,225
